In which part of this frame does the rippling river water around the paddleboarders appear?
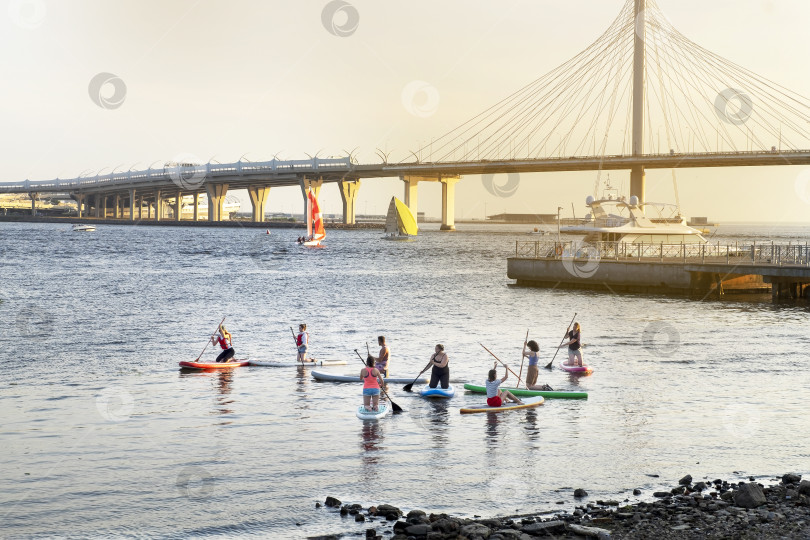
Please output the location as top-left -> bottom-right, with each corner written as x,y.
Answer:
0,223 -> 810,537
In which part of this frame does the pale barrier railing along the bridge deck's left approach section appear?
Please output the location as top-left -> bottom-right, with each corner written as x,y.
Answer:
0,156 -> 353,193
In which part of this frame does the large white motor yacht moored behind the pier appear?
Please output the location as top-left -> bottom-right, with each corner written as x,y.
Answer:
560,195 -> 707,244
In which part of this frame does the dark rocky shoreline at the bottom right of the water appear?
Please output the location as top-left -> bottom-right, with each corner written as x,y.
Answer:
311,473 -> 810,540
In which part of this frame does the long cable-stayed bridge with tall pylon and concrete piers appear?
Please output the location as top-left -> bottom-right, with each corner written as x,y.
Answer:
0,0 -> 810,229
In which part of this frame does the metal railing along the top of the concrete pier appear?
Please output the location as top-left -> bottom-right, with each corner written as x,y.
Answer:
515,240 -> 810,266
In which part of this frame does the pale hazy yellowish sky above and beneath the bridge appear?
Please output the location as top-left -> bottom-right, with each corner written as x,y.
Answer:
0,0 -> 810,222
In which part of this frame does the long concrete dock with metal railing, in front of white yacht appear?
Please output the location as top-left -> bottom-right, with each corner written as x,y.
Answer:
506,240 -> 810,300
